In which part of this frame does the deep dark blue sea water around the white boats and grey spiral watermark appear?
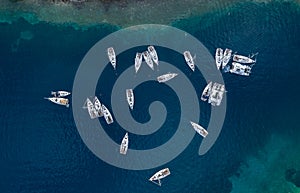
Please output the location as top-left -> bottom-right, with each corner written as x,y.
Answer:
0,2 -> 300,193
